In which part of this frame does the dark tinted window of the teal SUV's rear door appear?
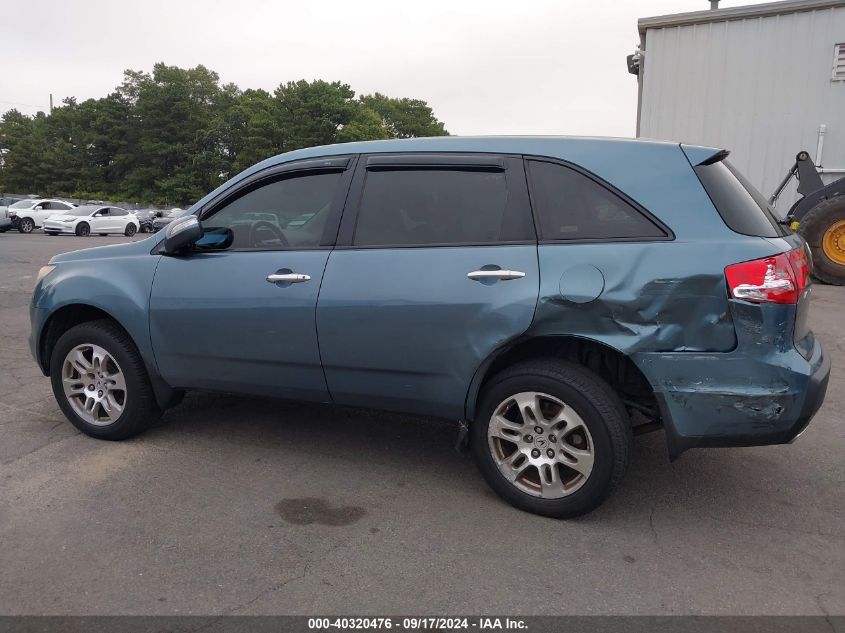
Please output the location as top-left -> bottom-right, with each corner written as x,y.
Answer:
352,168 -> 533,246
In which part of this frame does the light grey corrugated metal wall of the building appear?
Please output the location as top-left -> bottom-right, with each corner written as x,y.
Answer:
639,8 -> 845,212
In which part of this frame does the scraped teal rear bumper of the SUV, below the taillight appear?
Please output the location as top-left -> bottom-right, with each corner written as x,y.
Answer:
640,341 -> 830,460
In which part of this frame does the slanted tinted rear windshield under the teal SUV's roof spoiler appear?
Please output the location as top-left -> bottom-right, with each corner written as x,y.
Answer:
695,161 -> 789,237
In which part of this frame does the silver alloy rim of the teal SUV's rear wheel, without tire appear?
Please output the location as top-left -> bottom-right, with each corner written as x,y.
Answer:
487,391 -> 595,499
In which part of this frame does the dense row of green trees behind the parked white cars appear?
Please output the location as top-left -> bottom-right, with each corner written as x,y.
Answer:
0,63 -> 448,205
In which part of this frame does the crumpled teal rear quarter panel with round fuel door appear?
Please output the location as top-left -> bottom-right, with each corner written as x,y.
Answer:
529,240 -> 744,354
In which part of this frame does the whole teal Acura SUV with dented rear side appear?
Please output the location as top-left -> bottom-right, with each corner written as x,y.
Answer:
30,137 -> 830,517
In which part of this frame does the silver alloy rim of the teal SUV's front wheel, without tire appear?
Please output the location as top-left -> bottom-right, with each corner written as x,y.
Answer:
62,343 -> 128,426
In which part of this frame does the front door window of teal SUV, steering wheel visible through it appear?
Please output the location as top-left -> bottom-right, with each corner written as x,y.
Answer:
203,172 -> 342,250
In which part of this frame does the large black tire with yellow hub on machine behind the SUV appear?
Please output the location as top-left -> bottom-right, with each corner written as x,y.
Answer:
798,196 -> 845,286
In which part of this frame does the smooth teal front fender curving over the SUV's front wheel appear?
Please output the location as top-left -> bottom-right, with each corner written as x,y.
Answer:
33,254 -> 160,373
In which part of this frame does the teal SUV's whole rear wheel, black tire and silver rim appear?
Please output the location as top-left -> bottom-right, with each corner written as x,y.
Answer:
471,359 -> 632,519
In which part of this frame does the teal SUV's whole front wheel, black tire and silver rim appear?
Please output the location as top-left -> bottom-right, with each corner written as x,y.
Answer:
50,319 -> 161,440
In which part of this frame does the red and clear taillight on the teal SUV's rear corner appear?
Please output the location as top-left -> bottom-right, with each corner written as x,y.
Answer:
725,248 -> 810,303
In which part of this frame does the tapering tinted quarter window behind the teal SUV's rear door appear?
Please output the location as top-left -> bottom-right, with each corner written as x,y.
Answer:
528,160 -> 667,240
